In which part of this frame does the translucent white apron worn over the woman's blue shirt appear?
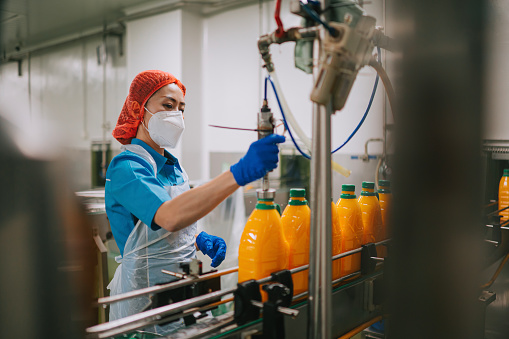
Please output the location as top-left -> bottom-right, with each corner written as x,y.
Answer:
108,144 -> 198,334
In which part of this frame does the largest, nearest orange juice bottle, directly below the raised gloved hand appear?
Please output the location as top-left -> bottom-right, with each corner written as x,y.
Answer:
238,190 -> 289,301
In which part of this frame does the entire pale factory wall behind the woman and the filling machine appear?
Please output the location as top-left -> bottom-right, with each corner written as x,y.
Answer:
0,1 -> 384,189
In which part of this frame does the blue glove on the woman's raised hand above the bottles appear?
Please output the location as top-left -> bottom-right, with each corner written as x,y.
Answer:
230,134 -> 285,186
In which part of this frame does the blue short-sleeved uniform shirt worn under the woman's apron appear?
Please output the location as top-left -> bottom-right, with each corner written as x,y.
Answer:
104,139 -> 184,255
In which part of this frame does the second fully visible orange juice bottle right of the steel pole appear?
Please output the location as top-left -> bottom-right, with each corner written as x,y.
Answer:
359,181 -> 383,244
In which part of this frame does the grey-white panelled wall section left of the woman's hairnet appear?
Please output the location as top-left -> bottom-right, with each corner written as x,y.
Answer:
0,37 -> 126,193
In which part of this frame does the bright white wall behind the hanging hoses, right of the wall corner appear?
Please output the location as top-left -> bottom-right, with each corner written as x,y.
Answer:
204,1 -> 383,153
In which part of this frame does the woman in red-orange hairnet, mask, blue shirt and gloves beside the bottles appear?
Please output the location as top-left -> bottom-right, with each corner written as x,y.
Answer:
105,70 -> 284,333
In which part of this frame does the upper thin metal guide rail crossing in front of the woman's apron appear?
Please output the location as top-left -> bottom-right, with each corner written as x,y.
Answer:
97,266 -> 239,305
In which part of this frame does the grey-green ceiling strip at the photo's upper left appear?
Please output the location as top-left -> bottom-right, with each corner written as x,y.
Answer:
0,0 -> 267,61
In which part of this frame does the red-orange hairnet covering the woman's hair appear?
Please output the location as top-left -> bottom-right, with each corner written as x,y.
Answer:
112,70 -> 186,145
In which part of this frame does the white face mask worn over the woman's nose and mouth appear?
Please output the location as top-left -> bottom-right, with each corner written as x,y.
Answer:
143,107 -> 186,148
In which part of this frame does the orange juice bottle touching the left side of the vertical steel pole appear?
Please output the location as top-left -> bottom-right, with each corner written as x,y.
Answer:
281,188 -> 311,295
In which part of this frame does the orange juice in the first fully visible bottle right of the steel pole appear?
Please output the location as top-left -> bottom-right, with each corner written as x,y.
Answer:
336,194 -> 363,276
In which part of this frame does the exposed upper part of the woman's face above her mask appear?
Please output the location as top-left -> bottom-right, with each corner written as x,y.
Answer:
144,84 -> 186,126
